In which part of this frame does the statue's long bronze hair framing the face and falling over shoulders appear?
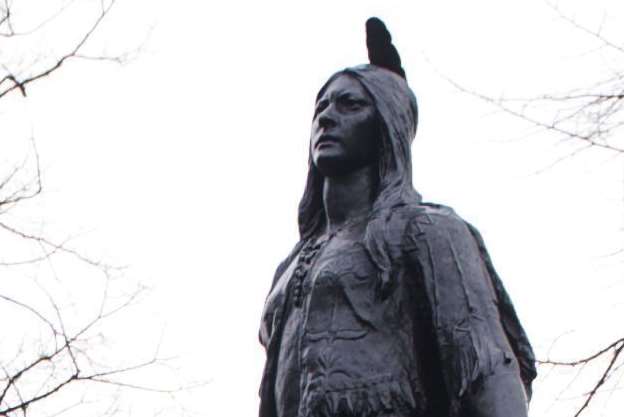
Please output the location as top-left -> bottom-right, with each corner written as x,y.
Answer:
298,65 -> 421,287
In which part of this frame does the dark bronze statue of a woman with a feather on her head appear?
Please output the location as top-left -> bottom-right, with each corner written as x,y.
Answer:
260,18 -> 536,417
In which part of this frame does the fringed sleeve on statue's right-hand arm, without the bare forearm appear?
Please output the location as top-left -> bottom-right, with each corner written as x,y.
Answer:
403,208 -> 530,415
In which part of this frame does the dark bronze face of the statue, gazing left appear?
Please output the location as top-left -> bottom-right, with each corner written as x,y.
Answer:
310,74 -> 379,177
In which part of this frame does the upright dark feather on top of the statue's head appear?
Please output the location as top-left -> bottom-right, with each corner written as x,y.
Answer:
366,17 -> 405,78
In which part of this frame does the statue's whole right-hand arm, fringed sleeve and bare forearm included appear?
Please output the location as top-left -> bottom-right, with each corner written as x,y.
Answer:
404,210 -> 527,417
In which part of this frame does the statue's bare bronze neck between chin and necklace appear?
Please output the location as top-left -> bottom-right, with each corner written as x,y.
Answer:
323,164 -> 378,232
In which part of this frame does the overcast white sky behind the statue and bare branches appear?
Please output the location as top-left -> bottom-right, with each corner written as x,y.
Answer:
0,0 -> 624,417
